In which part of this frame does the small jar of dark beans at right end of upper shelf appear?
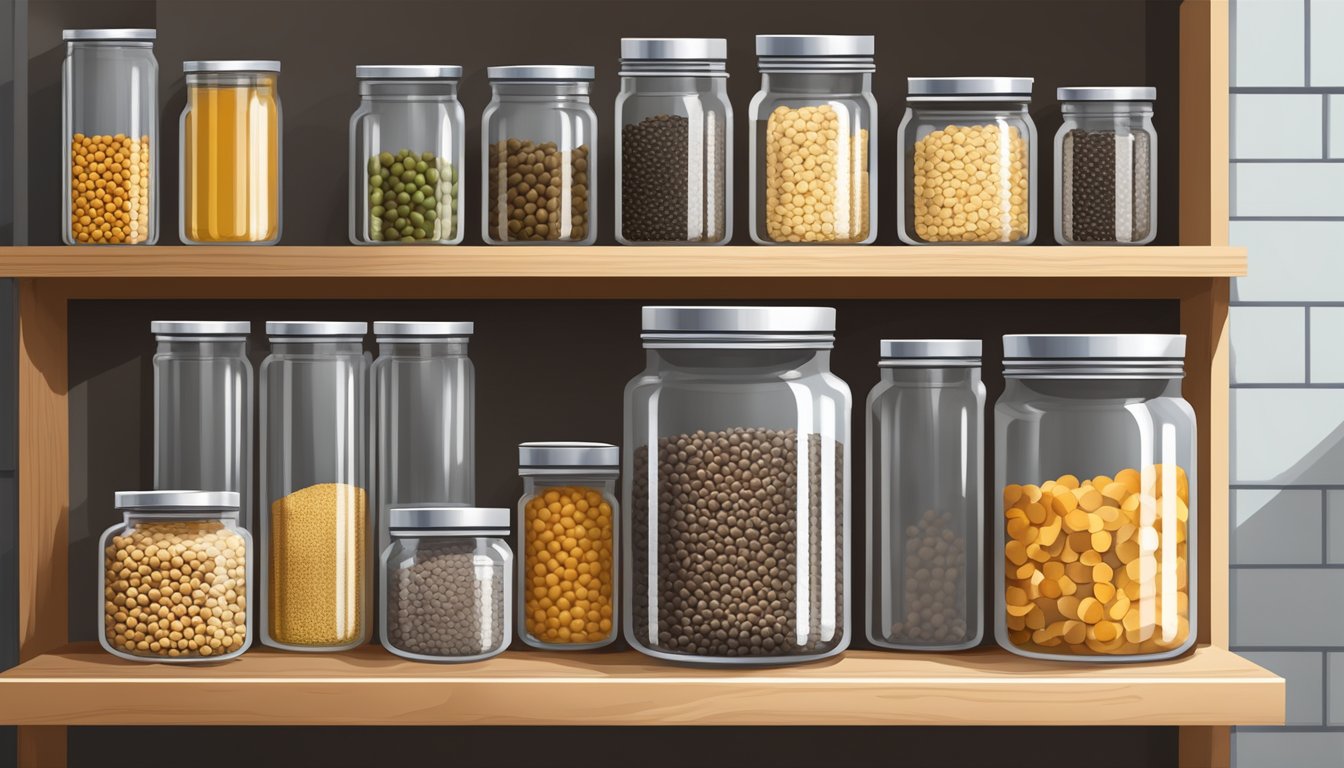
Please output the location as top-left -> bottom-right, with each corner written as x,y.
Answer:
1055,87 -> 1157,245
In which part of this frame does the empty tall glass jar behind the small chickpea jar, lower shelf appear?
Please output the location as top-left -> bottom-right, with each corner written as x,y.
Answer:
149,320 -> 253,527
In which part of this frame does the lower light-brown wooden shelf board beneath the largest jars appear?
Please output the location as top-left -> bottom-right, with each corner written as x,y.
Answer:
0,643 -> 1285,725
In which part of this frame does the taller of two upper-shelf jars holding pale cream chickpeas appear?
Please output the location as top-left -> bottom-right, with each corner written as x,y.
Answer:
750,35 -> 878,245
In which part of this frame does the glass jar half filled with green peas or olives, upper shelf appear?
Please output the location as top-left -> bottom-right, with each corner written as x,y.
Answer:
349,66 -> 466,245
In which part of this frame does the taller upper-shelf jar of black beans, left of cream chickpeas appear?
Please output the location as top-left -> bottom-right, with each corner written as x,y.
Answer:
616,38 -> 732,245
